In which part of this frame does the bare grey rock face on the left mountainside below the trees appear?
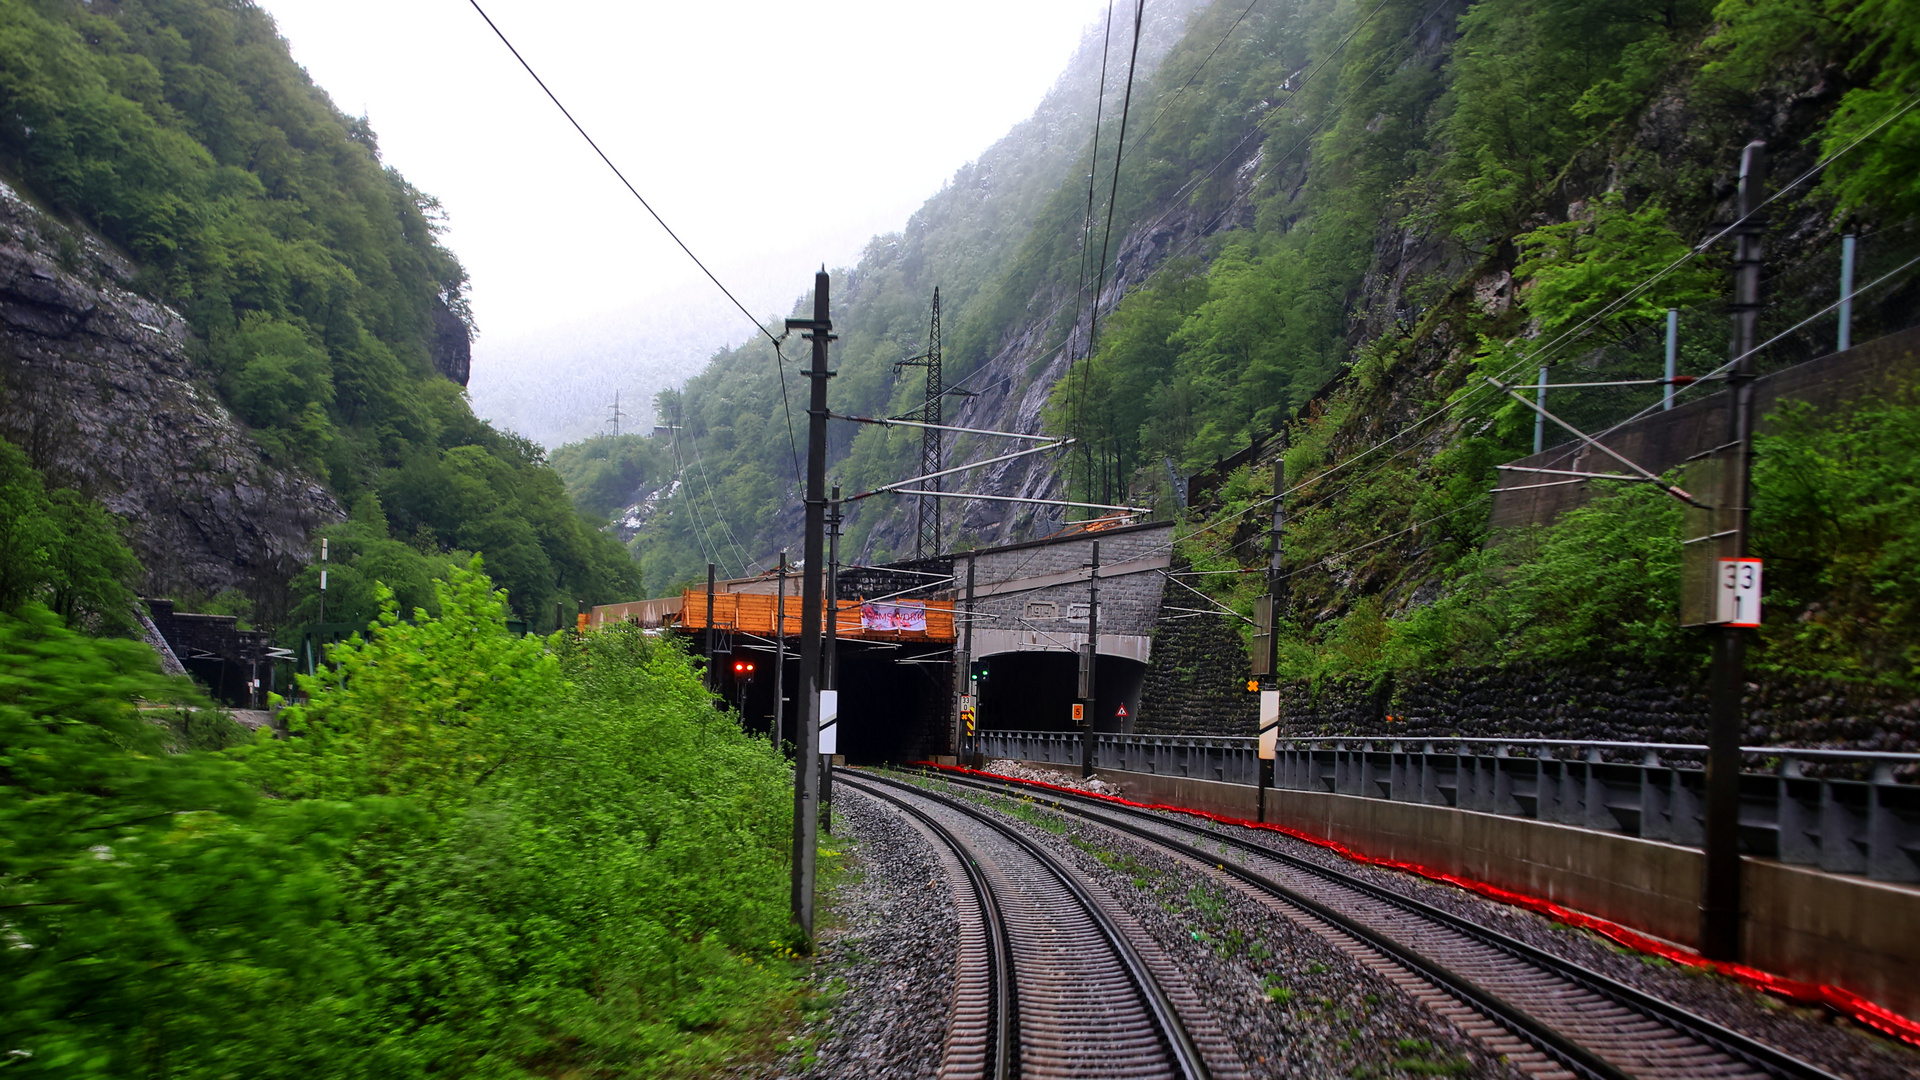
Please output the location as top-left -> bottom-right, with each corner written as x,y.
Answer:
0,183 -> 341,615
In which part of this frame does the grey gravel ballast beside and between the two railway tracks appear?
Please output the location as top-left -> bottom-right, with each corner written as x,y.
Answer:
774,771 -> 1920,1080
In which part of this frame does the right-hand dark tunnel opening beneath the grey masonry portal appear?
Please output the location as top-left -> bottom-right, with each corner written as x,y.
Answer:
977,651 -> 1146,732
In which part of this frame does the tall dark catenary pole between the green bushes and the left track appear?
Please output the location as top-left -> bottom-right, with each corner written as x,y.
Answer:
787,267 -> 833,949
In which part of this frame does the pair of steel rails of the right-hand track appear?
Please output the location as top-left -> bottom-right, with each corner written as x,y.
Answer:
917,774 -> 1839,1080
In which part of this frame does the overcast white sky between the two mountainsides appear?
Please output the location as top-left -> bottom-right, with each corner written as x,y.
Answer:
259,0 -> 1104,343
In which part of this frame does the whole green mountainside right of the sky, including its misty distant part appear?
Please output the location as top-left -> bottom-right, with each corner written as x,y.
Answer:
587,0 -> 1920,678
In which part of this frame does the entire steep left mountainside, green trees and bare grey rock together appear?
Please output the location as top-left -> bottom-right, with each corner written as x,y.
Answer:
0,0 -> 637,625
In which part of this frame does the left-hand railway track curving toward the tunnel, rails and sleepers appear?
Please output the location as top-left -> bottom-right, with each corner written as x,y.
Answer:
835,773 -> 1244,1080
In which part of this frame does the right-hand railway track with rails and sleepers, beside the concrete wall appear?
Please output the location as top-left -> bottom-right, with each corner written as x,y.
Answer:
898,774 -> 1836,1080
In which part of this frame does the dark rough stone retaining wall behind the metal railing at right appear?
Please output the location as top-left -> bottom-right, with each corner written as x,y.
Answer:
1135,617 -> 1920,753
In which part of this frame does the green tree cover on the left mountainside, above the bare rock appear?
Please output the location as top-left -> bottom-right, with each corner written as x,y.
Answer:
0,0 -> 637,619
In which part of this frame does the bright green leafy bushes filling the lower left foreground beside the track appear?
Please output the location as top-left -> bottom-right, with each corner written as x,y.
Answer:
0,561 -> 797,1080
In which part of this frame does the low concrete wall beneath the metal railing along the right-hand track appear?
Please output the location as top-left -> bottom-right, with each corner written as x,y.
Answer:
1027,761 -> 1920,1020
